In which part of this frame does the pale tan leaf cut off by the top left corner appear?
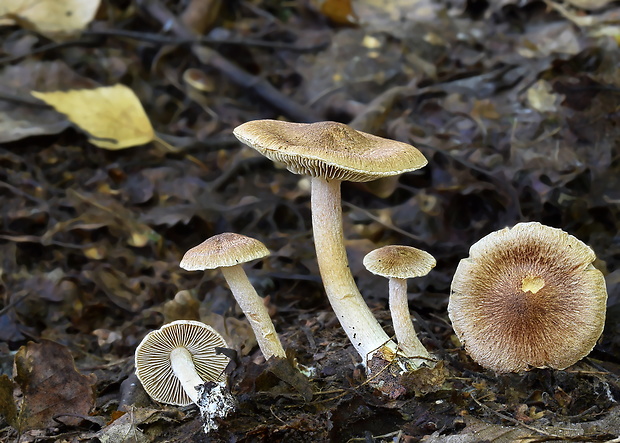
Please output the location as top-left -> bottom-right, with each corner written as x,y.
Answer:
0,0 -> 99,40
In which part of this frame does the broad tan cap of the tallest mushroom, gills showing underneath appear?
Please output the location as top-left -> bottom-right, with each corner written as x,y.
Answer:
234,120 -> 427,182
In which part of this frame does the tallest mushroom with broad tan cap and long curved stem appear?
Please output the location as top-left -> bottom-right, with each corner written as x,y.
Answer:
234,120 -> 427,364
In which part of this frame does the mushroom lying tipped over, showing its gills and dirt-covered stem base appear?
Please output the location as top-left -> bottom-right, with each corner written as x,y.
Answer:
135,320 -> 235,433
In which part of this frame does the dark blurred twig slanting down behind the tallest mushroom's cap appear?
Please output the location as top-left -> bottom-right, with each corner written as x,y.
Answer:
139,0 -> 321,122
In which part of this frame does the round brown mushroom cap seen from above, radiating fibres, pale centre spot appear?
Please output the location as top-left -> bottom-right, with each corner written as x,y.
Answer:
448,222 -> 607,372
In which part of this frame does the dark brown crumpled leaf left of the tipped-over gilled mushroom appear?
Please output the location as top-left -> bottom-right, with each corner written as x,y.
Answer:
14,340 -> 95,431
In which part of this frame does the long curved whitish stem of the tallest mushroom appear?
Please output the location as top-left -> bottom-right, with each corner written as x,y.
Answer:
311,177 -> 396,364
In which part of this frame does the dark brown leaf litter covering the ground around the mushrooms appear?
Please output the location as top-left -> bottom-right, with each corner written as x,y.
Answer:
0,0 -> 620,442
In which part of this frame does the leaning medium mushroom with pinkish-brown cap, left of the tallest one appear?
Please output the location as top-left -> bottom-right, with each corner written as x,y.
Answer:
180,232 -> 286,360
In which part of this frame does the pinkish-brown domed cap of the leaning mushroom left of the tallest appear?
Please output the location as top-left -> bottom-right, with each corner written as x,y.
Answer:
180,232 -> 269,271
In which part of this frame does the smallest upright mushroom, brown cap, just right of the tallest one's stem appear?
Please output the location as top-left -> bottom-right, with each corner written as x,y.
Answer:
363,245 -> 437,366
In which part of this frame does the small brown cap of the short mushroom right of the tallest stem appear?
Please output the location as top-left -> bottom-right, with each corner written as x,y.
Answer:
364,245 -> 437,278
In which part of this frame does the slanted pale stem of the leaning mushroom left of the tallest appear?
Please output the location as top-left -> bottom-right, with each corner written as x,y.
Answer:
220,265 -> 286,360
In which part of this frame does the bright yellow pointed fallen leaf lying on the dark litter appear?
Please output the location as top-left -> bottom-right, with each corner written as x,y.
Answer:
32,85 -> 155,150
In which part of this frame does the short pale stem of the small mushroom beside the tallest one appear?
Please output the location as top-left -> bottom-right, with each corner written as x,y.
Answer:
389,277 -> 431,363
